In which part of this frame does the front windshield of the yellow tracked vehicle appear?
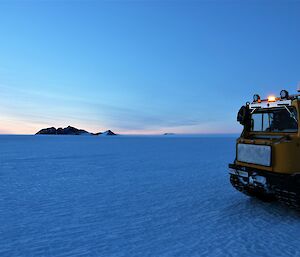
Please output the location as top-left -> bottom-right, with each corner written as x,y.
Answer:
251,107 -> 298,132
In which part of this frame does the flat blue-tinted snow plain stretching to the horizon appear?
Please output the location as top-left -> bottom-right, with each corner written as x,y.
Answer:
0,136 -> 300,257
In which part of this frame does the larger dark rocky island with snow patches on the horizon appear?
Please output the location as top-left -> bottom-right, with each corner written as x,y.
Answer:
36,126 -> 117,136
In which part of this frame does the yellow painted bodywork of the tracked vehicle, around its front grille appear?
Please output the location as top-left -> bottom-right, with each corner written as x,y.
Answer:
235,99 -> 300,174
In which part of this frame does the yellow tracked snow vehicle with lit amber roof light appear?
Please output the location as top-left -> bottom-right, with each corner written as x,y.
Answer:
229,90 -> 300,208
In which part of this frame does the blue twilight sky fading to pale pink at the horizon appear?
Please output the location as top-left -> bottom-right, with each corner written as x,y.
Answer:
0,1 -> 300,134
